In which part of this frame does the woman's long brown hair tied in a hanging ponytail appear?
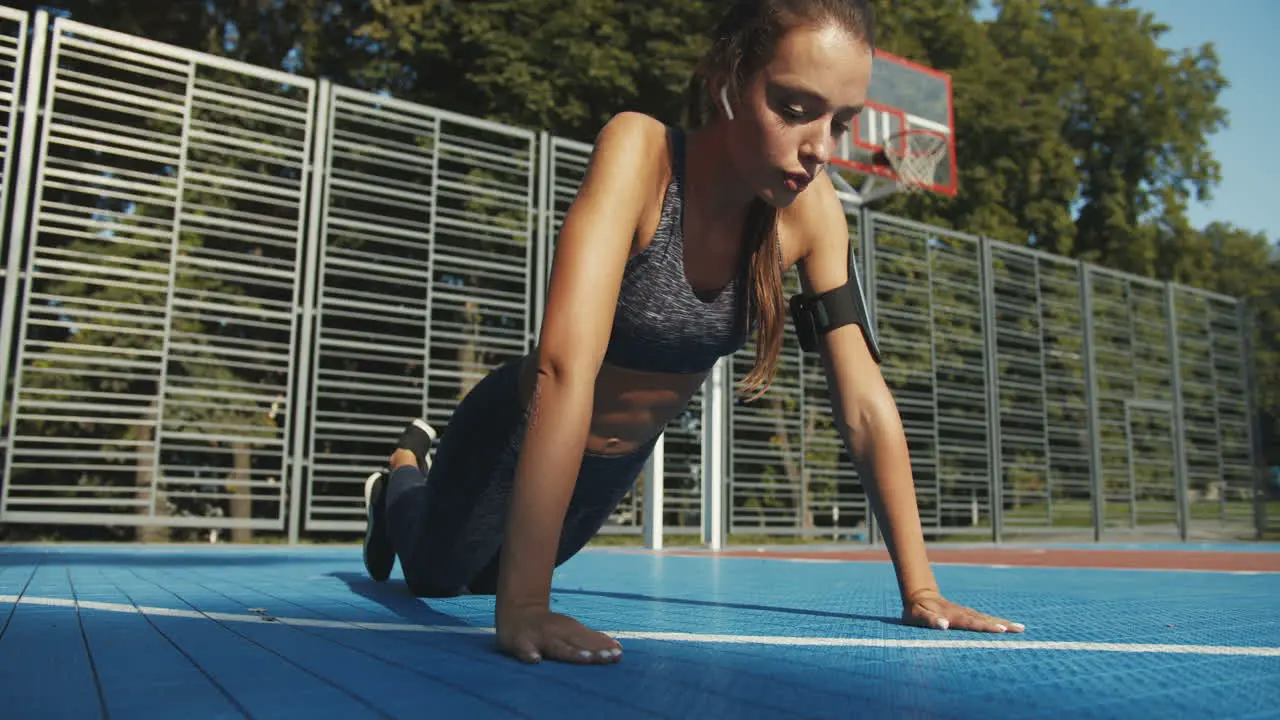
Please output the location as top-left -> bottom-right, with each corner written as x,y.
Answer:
685,0 -> 876,400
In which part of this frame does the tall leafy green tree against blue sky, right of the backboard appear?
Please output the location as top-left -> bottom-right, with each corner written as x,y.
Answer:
991,0 -> 1226,266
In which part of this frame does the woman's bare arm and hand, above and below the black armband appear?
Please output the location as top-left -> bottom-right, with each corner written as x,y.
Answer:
787,176 -> 1020,632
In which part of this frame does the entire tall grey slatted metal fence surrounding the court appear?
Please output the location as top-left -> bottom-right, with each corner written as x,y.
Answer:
0,9 -> 1261,546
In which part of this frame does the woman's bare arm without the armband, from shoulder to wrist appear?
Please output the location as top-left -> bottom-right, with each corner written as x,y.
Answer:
497,114 -> 666,655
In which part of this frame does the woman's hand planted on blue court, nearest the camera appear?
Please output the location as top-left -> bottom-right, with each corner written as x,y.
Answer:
498,609 -> 622,665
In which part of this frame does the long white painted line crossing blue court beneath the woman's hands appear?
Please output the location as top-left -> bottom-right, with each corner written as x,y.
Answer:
0,594 -> 1280,657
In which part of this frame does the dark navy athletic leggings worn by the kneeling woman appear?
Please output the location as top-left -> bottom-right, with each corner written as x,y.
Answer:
387,360 -> 657,597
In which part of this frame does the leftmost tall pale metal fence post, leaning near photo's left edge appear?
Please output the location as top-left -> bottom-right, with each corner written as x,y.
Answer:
0,10 -> 49,518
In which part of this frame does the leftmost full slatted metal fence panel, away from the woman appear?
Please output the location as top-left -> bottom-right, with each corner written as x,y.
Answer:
0,15 -> 315,529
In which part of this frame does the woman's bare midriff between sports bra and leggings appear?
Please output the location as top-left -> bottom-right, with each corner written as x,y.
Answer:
520,355 -> 707,455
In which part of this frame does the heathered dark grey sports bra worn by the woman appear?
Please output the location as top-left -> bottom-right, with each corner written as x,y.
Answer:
604,128 -> 750,373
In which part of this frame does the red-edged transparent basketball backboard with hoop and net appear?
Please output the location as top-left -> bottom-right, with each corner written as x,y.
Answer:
831,50 -> 957,205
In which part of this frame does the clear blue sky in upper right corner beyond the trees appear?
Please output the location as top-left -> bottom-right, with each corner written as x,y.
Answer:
979,0 -> 1280,243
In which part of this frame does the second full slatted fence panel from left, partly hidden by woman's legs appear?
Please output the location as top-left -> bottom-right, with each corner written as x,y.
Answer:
305,87 -> 539,530
